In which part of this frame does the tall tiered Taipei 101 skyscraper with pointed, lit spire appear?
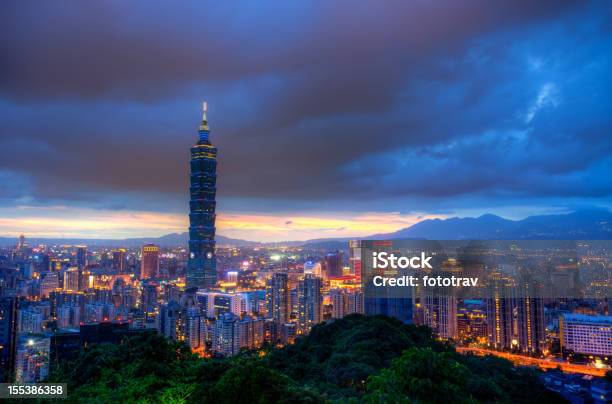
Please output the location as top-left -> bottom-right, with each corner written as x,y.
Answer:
187,102 -> 217,289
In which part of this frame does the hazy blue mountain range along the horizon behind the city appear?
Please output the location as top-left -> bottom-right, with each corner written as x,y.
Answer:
0,208 -> 612,249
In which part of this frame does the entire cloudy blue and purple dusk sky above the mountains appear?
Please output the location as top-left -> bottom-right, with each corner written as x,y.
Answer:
0,0 -> 612,240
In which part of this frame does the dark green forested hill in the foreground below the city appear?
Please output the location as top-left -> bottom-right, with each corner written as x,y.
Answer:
50,315 -> 563,404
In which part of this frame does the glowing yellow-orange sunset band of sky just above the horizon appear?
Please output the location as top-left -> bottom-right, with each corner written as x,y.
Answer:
0,206 -> 442,242
